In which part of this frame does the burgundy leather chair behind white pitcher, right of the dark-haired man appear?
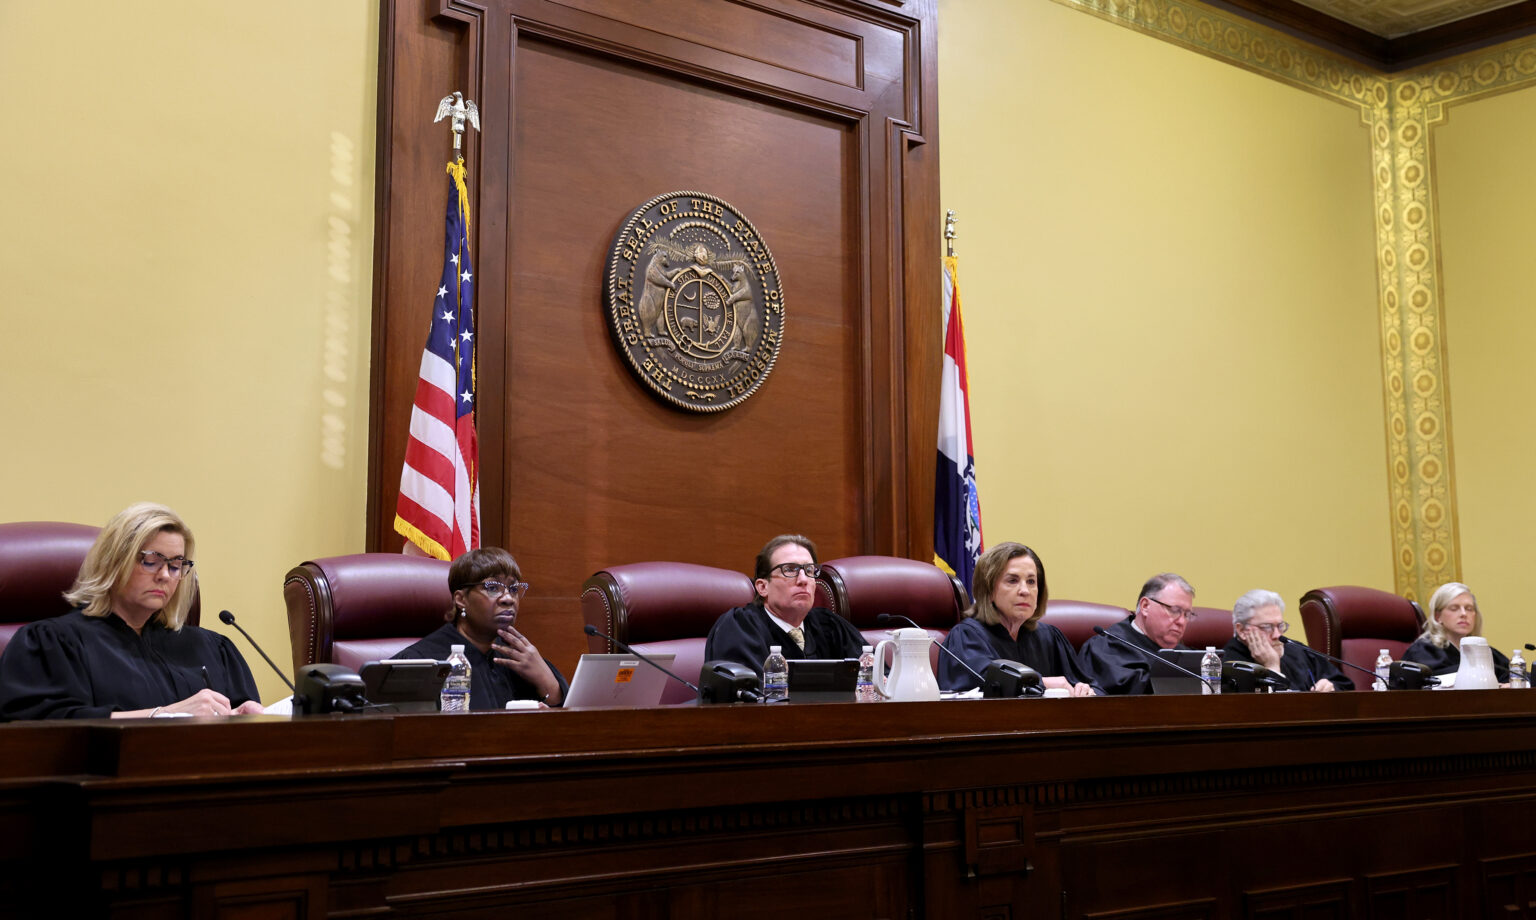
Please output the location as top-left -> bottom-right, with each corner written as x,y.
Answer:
816,556 -> 969,673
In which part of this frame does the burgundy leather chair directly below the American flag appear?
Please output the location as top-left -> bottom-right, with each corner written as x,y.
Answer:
283,553 -> 453,671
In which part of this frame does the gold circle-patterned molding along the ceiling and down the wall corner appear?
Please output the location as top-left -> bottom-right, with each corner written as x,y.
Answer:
1057,0 -> 1536,599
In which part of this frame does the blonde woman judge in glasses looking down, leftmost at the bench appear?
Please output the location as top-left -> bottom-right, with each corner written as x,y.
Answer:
0,502 -> 261,719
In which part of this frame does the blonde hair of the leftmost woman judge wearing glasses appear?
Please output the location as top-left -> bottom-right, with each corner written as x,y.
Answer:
65,502 -> 197,630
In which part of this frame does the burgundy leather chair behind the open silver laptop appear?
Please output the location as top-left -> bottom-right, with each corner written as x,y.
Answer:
581,562 -> 754,703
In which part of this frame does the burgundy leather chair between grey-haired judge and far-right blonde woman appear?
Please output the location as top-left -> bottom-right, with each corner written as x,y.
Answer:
1301,585 -> 1424,690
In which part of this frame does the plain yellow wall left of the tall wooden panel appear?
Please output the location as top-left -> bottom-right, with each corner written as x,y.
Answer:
0,0 -> 380,702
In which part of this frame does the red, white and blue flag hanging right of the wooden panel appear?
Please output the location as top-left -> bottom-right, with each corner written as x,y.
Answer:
934,256 -> 983,591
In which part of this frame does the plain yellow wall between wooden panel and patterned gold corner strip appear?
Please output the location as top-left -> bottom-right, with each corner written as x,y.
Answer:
935,0 -> 1393,627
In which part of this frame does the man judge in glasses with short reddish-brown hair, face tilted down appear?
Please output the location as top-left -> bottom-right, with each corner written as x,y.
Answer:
1077,571 -> 1195,694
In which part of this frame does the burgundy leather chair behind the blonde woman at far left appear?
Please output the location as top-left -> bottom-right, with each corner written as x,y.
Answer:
0,521 -> 201,651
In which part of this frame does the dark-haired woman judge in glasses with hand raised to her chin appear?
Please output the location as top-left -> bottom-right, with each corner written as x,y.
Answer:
395,547 -> 570,710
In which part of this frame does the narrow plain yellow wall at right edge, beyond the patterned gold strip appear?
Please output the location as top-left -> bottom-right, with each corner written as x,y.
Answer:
1435,89 -> 1536,657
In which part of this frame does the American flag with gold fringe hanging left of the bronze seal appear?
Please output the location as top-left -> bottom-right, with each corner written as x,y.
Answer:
395,160 -> 479,559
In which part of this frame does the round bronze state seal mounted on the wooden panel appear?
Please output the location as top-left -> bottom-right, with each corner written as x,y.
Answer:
607,192 -> 783,412
